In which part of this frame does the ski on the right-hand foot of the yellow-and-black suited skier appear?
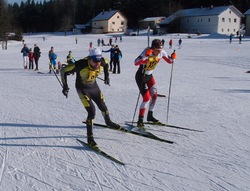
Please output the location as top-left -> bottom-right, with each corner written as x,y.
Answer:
83,121 -> 174,144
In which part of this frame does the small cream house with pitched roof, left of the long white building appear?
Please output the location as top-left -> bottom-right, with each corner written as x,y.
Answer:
91,10 -> 127,34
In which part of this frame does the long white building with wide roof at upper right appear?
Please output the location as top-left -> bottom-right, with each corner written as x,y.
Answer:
159,5 -> 244,35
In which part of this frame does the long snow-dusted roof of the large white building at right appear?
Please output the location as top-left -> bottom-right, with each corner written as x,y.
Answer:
159,5 -> 244,25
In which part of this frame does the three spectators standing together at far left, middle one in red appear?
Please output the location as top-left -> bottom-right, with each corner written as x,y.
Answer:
21,44 -> 41,71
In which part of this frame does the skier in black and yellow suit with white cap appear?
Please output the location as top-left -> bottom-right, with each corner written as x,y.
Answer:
61,48 -> 120,146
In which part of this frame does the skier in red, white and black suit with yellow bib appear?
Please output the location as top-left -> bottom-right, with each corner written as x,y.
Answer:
135,39 -> 176,129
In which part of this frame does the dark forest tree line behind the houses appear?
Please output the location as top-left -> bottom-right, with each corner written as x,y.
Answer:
0,0 -> 250,34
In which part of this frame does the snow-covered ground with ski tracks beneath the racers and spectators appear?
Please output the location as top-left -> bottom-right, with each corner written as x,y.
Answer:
0,34 -> 250,191
